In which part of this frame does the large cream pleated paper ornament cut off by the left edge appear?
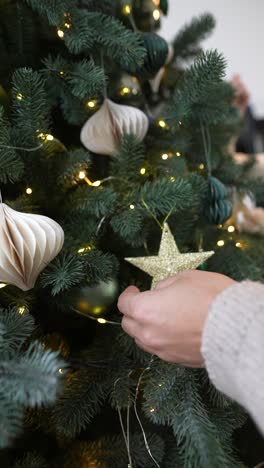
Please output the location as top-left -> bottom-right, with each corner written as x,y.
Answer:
0,203 -> 64,291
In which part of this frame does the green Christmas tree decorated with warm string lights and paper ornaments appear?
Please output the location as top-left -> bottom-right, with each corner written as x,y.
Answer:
0,0 -> 264,468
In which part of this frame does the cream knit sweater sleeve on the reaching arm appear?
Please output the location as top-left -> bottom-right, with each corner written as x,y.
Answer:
202,281 -> 264,433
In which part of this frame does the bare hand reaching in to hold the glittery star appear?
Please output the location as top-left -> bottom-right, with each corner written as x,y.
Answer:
118,270 -> 235,367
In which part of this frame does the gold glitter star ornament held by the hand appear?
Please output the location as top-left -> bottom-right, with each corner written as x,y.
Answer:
125,224 -> 214,289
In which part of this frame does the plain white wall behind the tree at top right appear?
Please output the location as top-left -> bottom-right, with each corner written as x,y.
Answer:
160,0 -> 264,118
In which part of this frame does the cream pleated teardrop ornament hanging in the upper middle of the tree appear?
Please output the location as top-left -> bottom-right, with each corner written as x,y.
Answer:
81,99 -> 149,156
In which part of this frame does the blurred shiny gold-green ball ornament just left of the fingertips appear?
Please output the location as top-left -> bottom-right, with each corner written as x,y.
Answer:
72,279 -> 119,318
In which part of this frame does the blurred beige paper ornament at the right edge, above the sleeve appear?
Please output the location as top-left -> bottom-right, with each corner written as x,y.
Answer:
233,194 -> 264,236
